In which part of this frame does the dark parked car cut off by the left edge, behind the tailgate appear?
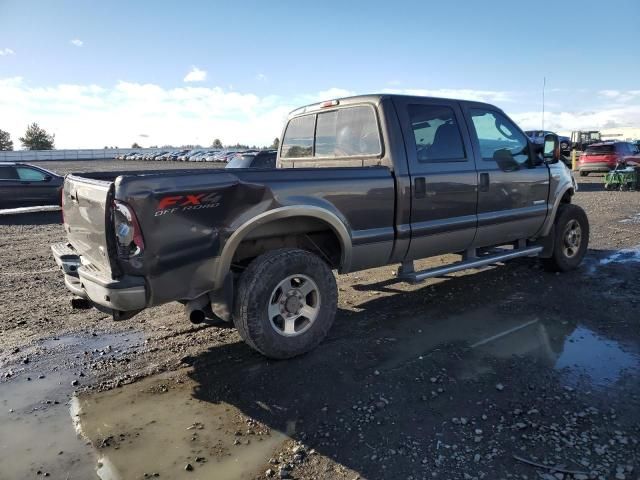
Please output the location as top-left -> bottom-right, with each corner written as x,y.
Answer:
0,162 -> 64,209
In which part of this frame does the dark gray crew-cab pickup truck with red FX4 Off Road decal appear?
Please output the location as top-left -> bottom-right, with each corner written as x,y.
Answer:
52,95 -> 589,358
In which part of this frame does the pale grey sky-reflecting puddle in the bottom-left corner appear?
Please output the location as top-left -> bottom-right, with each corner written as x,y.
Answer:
0,332 -> 142,480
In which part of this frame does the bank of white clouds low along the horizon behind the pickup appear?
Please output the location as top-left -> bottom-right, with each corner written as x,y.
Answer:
0,77 -> 640,148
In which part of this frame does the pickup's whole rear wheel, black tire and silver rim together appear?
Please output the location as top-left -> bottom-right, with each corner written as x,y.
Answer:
233,249 -> 338,359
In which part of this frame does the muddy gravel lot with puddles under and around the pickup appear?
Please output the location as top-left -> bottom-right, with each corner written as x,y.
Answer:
0,161 -> 640,479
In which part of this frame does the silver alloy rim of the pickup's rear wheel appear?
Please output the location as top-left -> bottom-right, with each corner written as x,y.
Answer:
267,274 -> 320,337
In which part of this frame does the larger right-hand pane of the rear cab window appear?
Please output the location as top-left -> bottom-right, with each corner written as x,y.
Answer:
314,105 -> 381,157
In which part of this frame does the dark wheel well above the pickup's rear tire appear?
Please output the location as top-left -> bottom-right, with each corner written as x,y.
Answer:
232,217 -> 342,268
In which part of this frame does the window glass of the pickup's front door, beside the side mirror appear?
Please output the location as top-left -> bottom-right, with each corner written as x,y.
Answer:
470,108 -> 529,165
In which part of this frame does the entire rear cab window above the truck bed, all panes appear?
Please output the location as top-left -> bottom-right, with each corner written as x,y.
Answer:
280,105 -> 382,160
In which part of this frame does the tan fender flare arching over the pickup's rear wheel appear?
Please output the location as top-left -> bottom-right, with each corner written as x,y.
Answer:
214,205 -> 352,288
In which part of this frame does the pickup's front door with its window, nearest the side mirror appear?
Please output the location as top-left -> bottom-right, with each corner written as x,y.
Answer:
464,104 -> 550,247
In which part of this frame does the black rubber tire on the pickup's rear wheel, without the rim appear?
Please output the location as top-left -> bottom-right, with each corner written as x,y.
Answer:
233,248 -> 338,359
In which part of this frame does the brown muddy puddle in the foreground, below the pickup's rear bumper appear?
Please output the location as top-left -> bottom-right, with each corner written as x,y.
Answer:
74,376 -> 293,480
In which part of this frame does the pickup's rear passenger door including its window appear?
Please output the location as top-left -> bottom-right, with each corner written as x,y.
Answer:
393,97 -> 477,260
